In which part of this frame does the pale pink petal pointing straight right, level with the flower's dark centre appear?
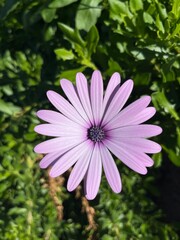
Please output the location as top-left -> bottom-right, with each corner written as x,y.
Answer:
106,124 -> 162,138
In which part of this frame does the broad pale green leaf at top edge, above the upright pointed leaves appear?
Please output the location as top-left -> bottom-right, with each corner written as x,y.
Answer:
75,0 -> 102,32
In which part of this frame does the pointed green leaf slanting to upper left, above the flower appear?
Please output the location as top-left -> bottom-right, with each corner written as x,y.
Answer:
58,23 -> 85,47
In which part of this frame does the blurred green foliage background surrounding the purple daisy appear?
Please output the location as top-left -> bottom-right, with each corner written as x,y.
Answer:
0,0 -> 180,240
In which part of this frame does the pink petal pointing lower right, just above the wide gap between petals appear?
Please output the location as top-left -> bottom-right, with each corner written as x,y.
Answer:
103,140 -> 147,174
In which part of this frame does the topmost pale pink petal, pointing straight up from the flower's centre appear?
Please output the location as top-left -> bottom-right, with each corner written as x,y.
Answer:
90,70 -> 103,126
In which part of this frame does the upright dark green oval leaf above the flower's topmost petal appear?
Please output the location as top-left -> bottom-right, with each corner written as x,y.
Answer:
87,26 -> 99,57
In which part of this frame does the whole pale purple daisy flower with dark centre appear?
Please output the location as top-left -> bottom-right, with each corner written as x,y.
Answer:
34,70 -> 162,200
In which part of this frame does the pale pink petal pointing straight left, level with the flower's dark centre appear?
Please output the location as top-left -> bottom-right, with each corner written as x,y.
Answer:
34,124 -> 87,137
